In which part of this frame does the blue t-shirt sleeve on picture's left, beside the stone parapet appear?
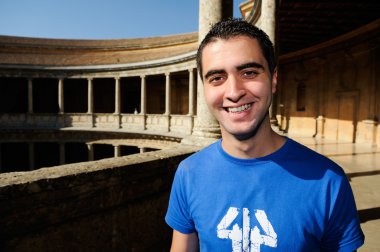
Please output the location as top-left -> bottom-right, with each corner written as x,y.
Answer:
165,165 -> 196,234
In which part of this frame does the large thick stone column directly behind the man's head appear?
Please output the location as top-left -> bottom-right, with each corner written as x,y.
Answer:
183,0 -> 233,145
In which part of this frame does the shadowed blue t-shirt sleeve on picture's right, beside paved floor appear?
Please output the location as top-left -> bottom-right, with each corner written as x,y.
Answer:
322,177 -> 364,251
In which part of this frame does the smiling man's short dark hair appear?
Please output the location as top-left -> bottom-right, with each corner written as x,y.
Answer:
197,18 -> 276,79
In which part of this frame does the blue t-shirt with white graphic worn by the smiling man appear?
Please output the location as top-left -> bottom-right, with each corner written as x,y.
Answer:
165,139 -> 364,252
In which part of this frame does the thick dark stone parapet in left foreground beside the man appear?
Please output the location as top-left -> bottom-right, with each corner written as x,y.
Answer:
0,145 -> 196,251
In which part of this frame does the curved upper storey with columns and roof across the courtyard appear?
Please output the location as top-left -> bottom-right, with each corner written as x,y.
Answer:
0,33 -> 198,136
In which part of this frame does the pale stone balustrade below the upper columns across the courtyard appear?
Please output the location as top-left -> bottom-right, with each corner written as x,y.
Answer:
0,113 -> 194,135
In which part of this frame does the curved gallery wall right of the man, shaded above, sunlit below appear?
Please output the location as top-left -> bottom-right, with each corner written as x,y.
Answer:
276,22 -> 380,144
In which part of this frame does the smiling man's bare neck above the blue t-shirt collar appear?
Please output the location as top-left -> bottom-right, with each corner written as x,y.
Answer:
222,117 -> 285,158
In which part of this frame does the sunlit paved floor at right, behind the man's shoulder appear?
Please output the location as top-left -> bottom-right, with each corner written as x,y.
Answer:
292,137 -> 380,252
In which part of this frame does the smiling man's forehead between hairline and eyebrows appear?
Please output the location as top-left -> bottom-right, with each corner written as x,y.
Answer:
202,36 -> 267,71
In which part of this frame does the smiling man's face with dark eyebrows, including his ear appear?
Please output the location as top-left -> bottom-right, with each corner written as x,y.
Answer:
202,36 -> 277,139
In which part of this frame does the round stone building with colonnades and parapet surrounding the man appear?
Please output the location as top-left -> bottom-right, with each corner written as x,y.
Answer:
0,0 -> 380,251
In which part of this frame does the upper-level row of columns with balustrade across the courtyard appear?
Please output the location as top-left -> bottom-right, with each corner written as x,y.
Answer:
0,68 -> 196,134
